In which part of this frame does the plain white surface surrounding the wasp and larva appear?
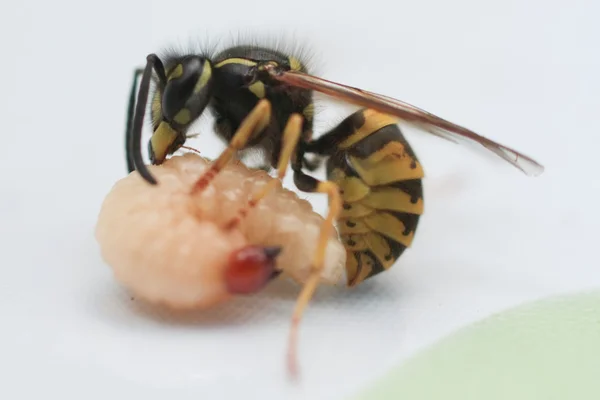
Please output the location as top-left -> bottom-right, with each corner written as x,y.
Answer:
0,0 -> 600,400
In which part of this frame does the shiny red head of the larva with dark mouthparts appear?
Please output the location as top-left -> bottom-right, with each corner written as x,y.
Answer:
225,246 -> 281,294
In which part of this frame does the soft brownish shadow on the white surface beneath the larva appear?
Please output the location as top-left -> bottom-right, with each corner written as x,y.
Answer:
84,267 -> 402,330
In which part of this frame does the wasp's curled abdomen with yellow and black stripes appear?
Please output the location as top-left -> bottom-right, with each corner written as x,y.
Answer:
327,110 -> 423,286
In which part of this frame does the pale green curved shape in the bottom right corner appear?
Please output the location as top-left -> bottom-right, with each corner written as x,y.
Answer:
355,291 -> 600,400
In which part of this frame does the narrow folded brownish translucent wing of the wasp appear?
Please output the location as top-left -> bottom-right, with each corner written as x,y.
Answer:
266,67 -> 544,176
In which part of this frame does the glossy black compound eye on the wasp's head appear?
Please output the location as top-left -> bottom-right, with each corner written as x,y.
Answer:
162,57 -> 203,122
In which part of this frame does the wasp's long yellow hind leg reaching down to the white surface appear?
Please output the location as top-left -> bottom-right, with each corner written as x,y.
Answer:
288,180 -> 342,376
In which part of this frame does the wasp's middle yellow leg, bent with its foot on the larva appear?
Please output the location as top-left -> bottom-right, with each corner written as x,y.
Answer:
226,114 -> 303,229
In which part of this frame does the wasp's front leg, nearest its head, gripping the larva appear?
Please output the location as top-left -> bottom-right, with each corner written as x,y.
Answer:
192,99 -> 271,193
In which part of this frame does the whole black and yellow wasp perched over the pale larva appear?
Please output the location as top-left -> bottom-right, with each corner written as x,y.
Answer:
126,45 -> 544,371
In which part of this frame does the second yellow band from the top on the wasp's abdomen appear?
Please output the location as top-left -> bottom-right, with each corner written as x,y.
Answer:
350,156 -> 424,186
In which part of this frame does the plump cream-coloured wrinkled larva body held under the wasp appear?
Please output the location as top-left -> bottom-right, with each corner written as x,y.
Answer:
96,153 -> 346,309
